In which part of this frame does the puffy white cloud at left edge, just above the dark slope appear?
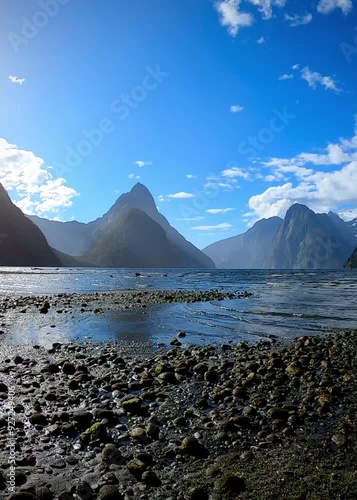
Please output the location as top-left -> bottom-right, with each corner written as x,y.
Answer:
0,138 -> 78,215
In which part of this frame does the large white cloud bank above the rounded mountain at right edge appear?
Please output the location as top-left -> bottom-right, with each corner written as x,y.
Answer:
246,118 -> 357,221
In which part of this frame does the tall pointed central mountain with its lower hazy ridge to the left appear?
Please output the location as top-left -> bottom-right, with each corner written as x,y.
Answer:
28,183 -> 215,269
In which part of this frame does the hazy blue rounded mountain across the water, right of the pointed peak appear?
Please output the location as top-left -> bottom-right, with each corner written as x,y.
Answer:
203,203 -> 357,269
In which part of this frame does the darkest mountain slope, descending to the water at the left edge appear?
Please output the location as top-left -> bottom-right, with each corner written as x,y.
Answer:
0,184 -> 61,267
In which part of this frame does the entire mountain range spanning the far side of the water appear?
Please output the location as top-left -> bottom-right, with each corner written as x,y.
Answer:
0,183 -> 357,269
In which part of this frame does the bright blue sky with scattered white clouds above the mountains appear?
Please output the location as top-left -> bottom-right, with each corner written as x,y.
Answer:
0,0 -> 357,248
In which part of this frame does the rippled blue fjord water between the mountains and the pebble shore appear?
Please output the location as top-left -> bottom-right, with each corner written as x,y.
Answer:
0,268 -> 357,344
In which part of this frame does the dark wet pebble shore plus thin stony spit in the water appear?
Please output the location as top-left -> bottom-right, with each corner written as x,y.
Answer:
0,292 -> 357,500
